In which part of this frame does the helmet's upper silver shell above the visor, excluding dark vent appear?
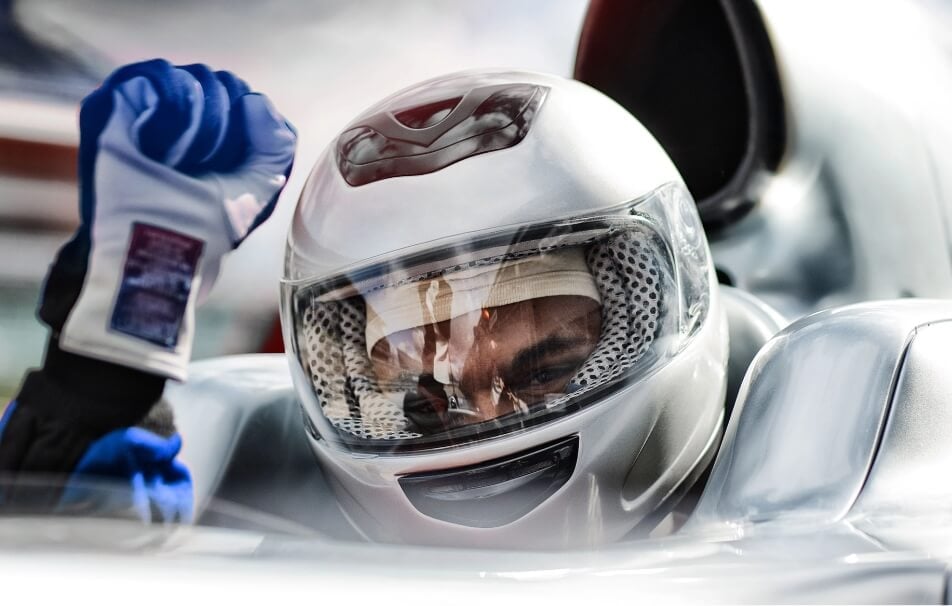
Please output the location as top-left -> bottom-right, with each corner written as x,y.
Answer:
285,72 -> 681,280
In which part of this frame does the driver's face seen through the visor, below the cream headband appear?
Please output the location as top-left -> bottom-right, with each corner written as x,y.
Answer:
371,295 -> 601,430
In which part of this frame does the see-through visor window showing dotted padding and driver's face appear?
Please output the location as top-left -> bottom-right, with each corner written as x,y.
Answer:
298,221 -> 672,441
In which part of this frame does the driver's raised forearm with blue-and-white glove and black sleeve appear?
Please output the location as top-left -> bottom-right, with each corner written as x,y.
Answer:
0,60 -> 296,510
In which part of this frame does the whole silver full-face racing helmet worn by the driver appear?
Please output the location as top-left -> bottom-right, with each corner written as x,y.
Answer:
282,71 -> 727,548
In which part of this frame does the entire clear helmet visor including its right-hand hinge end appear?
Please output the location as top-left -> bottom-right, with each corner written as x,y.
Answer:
284,186 -> 708,452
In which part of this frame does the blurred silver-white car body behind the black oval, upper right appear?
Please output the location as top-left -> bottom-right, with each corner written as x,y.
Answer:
711,0 -> 952,316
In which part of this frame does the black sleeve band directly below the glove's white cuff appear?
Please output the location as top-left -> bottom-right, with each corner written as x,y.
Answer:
17,339 -> 165,436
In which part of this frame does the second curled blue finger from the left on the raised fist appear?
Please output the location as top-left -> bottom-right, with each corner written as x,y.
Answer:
169,64 -> 231,174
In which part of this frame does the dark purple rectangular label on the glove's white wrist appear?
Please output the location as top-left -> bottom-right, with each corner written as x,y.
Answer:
110,223 -> 204,349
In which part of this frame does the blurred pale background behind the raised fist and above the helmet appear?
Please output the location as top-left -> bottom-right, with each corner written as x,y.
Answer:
0,0 -> 587,405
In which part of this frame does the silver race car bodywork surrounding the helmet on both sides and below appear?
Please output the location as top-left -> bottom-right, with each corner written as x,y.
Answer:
48,295 -> 940,603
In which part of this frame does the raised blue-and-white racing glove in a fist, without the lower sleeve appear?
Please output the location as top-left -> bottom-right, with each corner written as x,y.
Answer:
40,60 -> 296,379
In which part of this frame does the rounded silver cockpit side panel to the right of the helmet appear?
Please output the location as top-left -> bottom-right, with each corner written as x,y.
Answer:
689,300 -> 952,526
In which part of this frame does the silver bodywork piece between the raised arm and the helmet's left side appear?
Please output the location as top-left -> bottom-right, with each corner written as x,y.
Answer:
165,355 -> 357,540
